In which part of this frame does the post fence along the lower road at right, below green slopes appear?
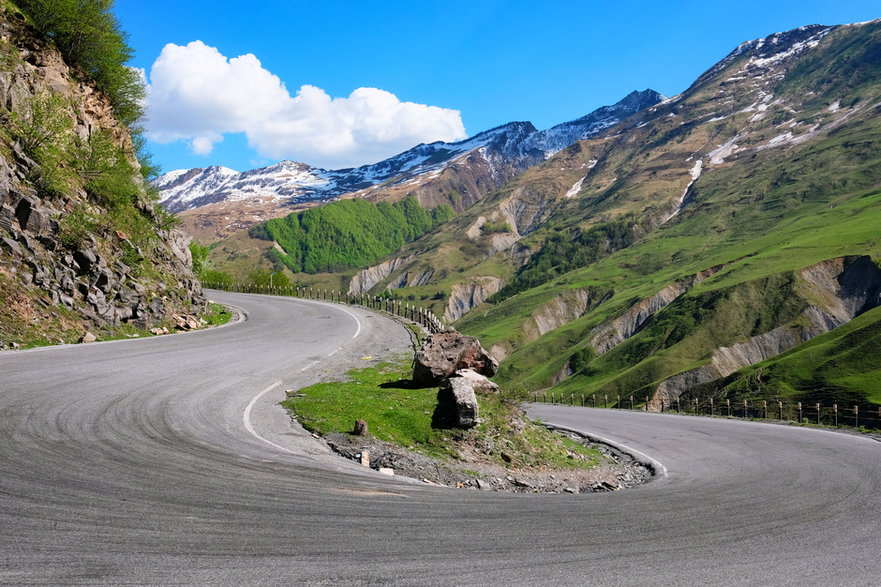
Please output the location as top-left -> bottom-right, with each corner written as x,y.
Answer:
533,391 -> 881,430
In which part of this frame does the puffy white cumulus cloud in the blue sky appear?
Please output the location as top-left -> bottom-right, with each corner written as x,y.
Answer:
147,41 -> 466,169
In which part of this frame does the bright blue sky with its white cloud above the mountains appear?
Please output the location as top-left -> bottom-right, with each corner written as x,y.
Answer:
114,0 -> 881,171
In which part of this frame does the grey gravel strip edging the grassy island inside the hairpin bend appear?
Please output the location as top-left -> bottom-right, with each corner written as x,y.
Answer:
323,431 -> 652,493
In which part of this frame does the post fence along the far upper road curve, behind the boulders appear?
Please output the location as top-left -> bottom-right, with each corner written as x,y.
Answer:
202,281 -> 446,334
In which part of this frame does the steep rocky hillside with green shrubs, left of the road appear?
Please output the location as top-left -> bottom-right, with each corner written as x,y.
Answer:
0,9 -> 206,348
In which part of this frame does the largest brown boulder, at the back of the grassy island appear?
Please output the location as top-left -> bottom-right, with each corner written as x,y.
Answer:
413,328 -> 499,387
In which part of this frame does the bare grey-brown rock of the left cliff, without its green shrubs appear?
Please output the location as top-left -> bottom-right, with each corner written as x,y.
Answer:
0,10 -> 206,346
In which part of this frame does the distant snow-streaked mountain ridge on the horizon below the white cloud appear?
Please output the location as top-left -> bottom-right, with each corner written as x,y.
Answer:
153,90 -> 663,212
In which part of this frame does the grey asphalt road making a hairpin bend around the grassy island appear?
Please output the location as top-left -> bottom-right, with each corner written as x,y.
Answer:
0,293 -> 881,585
